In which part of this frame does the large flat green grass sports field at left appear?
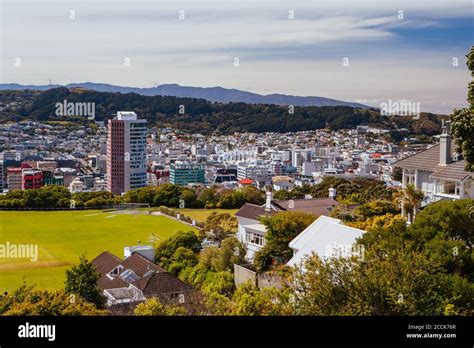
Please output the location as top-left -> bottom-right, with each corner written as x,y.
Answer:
0,210 -> 193,291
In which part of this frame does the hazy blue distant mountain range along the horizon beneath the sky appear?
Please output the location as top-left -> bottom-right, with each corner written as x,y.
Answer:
0,82 -> 369,109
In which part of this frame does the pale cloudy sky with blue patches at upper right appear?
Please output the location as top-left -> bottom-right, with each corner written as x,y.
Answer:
0,0 -> 474,113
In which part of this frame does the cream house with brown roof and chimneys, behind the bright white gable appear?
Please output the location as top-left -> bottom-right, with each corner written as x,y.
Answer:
235,189 -> 339,260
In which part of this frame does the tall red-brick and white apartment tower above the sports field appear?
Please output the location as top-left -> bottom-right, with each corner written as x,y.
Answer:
107,111 -> 147,194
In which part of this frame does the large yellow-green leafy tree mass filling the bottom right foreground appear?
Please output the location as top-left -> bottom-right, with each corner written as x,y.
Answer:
292,249 -> 474,315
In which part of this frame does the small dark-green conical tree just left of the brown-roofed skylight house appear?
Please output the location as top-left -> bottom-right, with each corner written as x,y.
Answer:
64,255 -> 105,308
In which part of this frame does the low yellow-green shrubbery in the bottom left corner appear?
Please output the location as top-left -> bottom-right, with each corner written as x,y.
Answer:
0,284 -> 107,316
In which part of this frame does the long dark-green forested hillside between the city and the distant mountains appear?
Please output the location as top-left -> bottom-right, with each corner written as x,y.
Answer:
0,87 -> 440,134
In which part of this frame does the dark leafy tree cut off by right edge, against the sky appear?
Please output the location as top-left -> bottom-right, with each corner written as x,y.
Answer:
451,46 -> 474,172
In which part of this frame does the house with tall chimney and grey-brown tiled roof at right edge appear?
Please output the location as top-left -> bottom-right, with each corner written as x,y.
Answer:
392,122 -> 474,215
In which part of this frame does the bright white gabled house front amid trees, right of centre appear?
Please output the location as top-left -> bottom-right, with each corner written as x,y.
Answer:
287,215 -> 365,266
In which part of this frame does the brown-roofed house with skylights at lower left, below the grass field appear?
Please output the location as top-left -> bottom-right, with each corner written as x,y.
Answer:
92,246 -> 195,313
